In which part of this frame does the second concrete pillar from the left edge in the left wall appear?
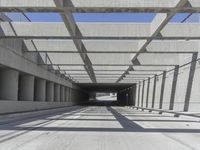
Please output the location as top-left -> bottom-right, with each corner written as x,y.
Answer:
18,74 -> 35,101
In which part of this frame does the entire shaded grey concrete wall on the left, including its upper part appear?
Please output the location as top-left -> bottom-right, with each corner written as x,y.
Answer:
0,39 -> 88,114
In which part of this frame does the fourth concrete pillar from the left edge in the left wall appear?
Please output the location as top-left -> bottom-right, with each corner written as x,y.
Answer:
46,81 -> 54,102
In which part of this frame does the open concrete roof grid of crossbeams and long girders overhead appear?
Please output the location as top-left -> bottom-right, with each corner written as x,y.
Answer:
0,0 -> 200,83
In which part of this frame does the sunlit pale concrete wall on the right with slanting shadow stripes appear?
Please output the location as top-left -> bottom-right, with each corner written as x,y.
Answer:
136,53 -> 200,112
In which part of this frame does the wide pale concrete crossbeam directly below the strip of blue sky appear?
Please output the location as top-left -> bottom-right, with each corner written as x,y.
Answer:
0,22 -> 200,39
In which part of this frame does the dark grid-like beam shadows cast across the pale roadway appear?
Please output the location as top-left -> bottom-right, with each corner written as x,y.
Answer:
0,107 -> 200,135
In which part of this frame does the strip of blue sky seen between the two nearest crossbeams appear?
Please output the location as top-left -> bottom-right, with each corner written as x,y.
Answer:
5,13 -> 195,23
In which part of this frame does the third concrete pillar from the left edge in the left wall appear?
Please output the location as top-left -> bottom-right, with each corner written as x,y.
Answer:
34,78 -> 46,101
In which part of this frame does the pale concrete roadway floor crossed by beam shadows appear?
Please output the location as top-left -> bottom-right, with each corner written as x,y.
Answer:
0,106 -> 200,150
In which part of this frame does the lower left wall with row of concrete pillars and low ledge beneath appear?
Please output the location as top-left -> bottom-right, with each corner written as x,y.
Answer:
0,66 -> 89,114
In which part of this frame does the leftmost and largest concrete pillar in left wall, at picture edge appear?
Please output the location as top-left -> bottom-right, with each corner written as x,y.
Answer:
0,68 -> 19,100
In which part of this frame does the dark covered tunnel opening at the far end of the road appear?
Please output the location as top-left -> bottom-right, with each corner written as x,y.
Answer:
79,83 -> 136,106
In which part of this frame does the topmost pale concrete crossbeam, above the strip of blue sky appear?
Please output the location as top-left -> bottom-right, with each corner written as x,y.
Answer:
0,0 -> 200,13
